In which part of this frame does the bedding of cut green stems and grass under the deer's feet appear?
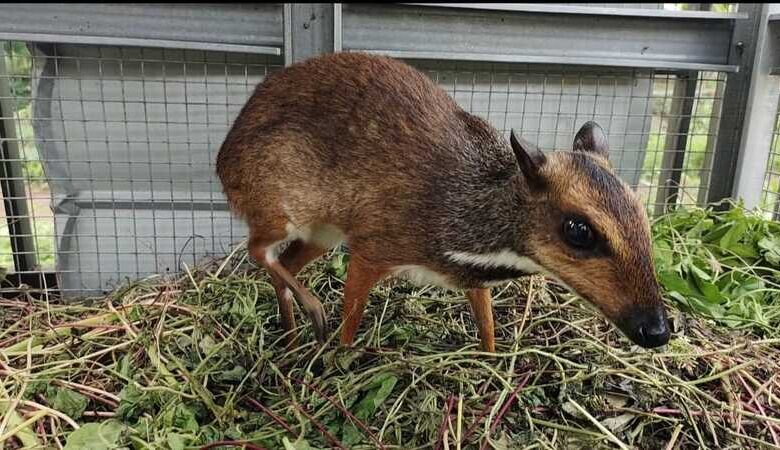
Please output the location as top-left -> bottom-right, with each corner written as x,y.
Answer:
0,220 -> 780,449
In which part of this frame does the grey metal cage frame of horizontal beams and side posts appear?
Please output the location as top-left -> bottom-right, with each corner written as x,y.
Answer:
0,3 -> 780,293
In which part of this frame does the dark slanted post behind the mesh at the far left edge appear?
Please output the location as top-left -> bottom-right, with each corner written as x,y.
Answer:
0,47 -> 36,272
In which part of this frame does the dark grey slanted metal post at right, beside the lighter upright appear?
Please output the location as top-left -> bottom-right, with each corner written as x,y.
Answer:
707,3 -> 766,202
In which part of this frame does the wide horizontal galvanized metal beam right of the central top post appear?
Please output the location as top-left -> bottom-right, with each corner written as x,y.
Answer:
342,4 -> 735,71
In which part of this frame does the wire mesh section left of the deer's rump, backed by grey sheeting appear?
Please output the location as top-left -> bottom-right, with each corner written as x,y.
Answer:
0,43 -> 281,294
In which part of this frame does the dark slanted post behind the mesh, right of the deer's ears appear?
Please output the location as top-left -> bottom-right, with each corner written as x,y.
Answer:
655,72 -> 699,215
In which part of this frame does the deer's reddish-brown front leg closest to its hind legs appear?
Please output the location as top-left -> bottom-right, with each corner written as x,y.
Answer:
341,253 -> 387,345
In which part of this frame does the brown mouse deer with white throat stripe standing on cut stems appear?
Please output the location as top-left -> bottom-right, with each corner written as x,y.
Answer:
217,53 -> 670,352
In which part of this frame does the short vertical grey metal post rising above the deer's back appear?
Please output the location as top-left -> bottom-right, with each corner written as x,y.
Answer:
284,3 -> 341,66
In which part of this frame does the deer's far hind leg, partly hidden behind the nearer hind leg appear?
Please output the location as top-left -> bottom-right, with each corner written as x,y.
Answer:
271,239 -> 327,348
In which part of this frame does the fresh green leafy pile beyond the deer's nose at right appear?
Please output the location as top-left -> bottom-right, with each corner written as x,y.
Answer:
652,205 -> 780,335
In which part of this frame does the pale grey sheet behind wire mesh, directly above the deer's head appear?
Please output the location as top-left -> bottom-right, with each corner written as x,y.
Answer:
412,62 -> 652,185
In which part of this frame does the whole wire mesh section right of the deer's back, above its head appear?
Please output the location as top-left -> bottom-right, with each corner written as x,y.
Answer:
412,61 -> 725,213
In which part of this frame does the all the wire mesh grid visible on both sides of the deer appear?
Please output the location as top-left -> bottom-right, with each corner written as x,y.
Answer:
0,42 -> 725,295
